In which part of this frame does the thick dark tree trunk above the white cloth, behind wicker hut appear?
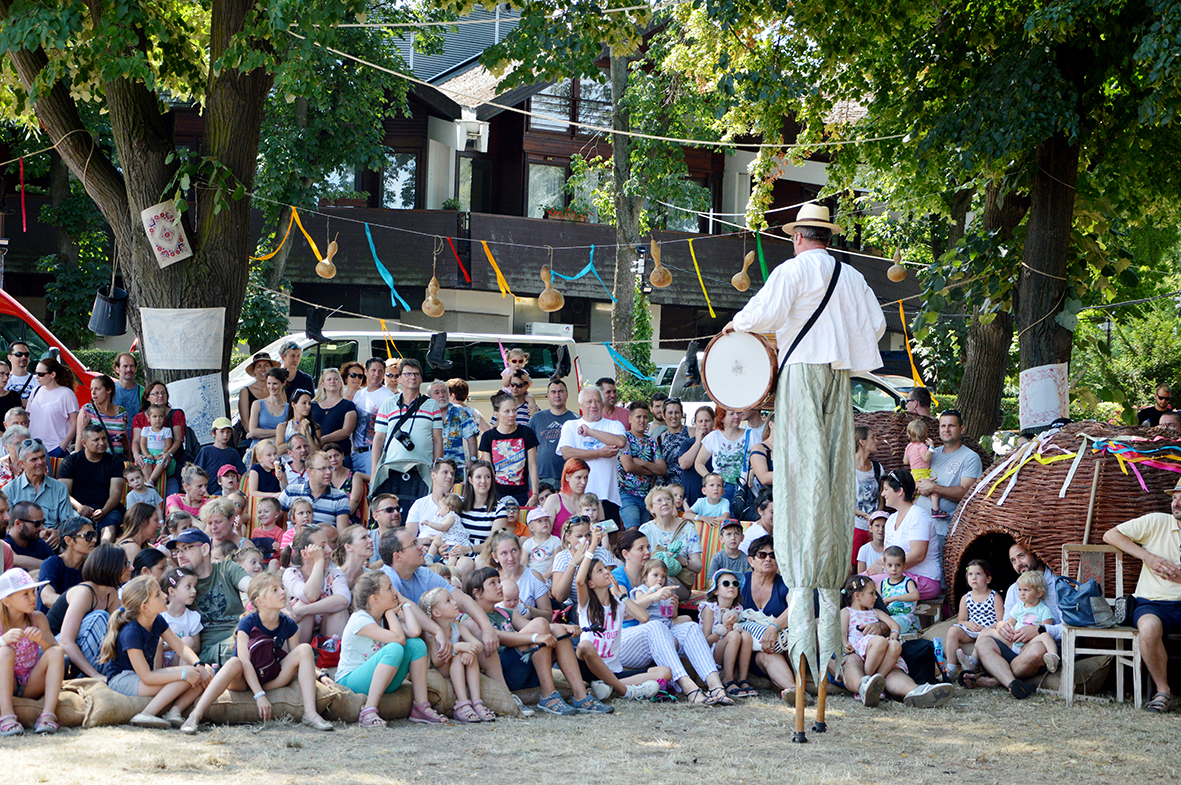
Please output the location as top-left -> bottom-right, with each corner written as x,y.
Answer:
1017,133 -> 1078,371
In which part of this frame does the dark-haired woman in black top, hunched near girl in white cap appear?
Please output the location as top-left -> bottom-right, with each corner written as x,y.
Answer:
45,544 -> 131,681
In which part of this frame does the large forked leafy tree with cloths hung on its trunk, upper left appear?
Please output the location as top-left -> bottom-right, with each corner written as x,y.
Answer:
0,0 -> 415,379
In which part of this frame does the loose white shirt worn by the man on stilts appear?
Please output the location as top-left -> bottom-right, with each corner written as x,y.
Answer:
733,249 -> 886,371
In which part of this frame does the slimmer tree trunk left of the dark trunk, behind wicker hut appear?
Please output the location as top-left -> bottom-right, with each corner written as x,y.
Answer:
955,181 -> 1029,438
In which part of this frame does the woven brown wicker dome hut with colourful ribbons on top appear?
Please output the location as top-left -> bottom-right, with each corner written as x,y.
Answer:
944,421 -> 1181,599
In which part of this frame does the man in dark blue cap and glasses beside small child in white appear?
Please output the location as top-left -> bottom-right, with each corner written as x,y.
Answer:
168,529 -> 250,665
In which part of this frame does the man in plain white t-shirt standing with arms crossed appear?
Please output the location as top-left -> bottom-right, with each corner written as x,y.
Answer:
557,385 -> 627,523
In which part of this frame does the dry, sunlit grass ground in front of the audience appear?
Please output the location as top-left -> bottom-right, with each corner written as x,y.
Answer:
0,691 -> 1181,785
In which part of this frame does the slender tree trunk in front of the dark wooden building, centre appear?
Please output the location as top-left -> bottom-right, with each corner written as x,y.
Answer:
611,54 -> 640,374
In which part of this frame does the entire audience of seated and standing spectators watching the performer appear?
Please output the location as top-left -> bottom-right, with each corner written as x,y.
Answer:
0,344 -> 1181,735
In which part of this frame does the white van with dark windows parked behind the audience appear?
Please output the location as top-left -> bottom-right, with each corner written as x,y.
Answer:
229,331 -> 582,418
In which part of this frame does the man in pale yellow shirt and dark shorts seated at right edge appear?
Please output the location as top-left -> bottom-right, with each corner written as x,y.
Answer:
1103,474 -> 1181,712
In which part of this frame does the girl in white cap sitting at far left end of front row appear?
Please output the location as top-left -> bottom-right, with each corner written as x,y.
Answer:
0,567 -> 66,735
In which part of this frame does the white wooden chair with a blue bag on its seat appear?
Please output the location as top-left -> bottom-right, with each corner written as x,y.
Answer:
1058,543 -> 1143,708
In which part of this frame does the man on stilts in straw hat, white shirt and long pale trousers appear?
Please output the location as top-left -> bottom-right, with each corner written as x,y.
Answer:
722,204 -> 886,741
